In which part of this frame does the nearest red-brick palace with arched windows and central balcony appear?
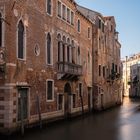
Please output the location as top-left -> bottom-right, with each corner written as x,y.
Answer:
0,0 -> 92,131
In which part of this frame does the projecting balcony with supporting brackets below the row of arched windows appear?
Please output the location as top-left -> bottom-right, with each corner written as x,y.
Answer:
57,62 -> 82,81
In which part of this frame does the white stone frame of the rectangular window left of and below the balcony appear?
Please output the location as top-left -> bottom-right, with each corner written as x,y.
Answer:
46,79 -> 54,102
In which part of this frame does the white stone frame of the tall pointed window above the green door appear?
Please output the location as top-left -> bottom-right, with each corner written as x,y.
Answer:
16,18 -> 27,61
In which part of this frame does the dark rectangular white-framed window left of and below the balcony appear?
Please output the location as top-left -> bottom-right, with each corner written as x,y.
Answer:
46,80 -> 54,100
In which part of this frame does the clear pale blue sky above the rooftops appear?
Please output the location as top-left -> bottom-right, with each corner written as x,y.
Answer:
75,0 -> 140,58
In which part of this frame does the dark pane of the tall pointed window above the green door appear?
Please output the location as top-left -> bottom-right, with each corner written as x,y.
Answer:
18,20 -> 25,59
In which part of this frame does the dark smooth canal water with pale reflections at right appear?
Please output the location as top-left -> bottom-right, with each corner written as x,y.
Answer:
0,98 -> 140,140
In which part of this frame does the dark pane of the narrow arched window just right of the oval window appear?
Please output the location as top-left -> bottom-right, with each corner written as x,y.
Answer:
47,33 -> 52,64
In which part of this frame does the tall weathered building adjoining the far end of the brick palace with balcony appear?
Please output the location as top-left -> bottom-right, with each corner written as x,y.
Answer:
78,6 -> 122,110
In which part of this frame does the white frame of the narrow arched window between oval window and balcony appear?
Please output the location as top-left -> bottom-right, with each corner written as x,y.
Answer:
45,32 -> 53,66
